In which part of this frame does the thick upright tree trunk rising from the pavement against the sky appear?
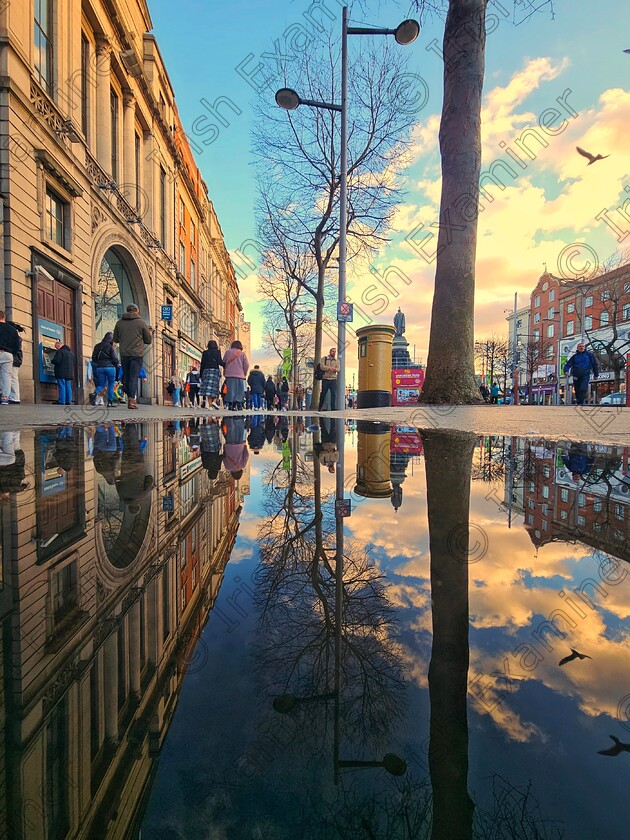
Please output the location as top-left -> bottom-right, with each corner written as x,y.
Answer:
421,0 -> 487,404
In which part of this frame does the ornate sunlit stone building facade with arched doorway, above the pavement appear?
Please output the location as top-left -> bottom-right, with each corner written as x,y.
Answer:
0,0 -> 243,403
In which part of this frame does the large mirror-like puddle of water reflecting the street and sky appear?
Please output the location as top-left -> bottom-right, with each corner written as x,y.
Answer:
0,416 -> 630,840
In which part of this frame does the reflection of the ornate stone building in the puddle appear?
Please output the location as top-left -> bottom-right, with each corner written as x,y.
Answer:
0,423 -> 241,840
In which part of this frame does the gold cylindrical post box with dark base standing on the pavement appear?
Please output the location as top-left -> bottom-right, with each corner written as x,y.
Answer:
357,324 -> 395,408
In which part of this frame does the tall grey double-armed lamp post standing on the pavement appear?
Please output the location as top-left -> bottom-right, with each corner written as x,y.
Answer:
275,6 -> 420,409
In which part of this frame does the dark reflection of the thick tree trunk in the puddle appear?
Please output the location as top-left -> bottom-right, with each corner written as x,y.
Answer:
423,432 -> 480,840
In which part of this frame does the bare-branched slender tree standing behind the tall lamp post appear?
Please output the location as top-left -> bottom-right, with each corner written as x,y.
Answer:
254,36 -> 413,399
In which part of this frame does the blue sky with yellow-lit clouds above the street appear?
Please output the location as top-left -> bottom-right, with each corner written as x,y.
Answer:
149,0 -> 630,370
